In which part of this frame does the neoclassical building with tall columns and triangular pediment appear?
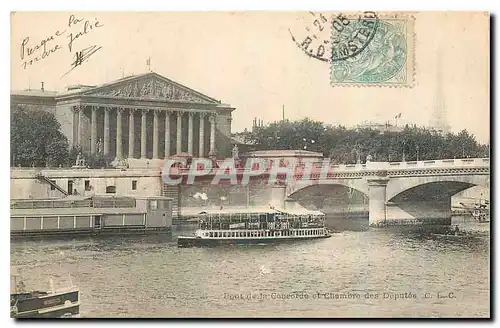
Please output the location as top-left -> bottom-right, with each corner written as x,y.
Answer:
11,72 -> 234,166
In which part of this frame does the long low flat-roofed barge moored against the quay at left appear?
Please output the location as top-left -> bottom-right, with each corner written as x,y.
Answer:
10,195 -> 172,238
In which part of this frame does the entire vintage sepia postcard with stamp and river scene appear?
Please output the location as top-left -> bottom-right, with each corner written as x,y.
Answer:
9,10 -> 491,318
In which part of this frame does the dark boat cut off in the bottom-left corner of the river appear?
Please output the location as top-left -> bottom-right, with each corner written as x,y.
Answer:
10,276 -> 80,319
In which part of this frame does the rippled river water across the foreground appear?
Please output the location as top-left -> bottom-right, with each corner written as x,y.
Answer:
11,218 -> 490,317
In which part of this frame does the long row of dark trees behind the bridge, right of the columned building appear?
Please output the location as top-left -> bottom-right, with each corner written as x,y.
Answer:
246,118 -> 489,164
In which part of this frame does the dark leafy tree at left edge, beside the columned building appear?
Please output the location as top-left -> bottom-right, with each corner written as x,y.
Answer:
10,106 -> 68,166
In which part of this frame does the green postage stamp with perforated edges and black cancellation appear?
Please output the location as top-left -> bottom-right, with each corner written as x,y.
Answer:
329,12 -> 415,87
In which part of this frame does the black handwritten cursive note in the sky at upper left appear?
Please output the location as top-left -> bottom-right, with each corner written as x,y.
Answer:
20,15 -> 104,76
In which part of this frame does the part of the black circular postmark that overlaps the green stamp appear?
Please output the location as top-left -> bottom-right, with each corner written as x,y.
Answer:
331,11 -> 379,62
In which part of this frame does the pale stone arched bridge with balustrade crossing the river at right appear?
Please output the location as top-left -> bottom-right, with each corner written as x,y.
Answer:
171,158 -> 490,226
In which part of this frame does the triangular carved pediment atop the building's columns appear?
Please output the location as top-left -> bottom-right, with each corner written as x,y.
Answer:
82,73 -> 220,104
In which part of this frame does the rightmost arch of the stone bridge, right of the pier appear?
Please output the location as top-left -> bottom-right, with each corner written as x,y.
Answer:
386,175 -> 489,201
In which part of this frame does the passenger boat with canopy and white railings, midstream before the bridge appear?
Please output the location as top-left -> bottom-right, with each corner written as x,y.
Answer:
177,208 -> 332,247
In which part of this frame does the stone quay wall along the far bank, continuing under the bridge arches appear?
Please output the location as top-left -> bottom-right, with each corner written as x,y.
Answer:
10,168 -> 480,224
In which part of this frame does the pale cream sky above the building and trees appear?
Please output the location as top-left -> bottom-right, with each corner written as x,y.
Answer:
11,12 -> 490,142
